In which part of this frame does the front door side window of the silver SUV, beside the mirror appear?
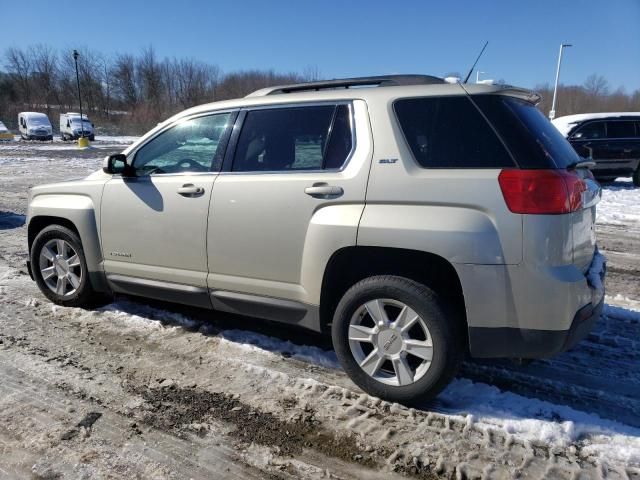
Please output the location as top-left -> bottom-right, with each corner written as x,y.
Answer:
133,113 -> 231,176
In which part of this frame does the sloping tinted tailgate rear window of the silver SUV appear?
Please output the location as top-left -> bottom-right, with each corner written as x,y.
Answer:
473,95 -> 580,168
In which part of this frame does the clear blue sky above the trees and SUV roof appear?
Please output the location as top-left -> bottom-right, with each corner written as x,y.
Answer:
5,0 -> 640,91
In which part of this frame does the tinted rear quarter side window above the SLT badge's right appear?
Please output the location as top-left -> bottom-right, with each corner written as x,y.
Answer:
395,97 -> 513,168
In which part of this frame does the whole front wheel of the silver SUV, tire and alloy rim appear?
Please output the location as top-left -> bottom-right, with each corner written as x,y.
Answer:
30,225 -> 106,308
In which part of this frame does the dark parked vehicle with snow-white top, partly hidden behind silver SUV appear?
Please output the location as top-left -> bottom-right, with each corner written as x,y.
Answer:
553,112 -> 640,187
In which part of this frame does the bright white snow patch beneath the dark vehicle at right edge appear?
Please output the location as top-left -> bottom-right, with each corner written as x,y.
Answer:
596,178 -> 640,226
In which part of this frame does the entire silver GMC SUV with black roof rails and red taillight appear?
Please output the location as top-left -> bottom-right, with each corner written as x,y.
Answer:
28,75 -> 604,403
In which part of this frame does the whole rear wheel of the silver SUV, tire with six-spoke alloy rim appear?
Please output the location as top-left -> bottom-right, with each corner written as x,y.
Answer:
331,275 -> 465,405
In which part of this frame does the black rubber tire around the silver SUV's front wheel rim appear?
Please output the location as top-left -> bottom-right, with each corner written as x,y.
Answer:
29,225 -> 108,308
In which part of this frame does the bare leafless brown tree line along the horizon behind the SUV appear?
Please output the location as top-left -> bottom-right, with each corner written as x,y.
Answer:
0,45 -> 640,134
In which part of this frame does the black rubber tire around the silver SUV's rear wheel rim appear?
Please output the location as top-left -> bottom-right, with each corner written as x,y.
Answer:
331,275 -> 465,405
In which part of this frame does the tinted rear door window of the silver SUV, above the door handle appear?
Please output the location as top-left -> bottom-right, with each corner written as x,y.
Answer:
232,105 -> 352,172
